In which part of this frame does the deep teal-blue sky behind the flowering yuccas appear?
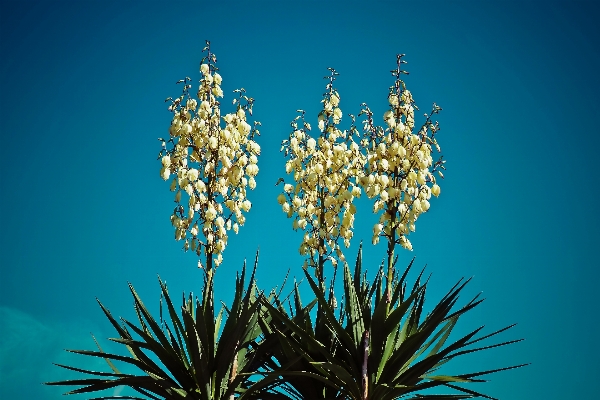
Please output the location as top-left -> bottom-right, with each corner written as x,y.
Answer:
0,1 -> 600,400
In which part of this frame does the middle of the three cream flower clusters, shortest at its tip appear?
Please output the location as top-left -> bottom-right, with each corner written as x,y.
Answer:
277,69 -> 365,276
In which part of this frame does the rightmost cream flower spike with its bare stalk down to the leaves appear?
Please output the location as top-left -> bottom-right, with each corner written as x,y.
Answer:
359,54 -> 445,303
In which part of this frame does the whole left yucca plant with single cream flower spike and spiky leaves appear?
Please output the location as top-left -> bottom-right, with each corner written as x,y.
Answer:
49,41 -> 274,400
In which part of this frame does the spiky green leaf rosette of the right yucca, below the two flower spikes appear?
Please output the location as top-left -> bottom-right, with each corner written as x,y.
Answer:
248,245 -> 522,400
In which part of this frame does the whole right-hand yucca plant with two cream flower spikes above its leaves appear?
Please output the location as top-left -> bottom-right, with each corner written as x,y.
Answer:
257,54 -> 528,400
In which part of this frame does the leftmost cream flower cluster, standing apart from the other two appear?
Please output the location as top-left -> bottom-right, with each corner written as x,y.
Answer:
159,42 -> 260,269
